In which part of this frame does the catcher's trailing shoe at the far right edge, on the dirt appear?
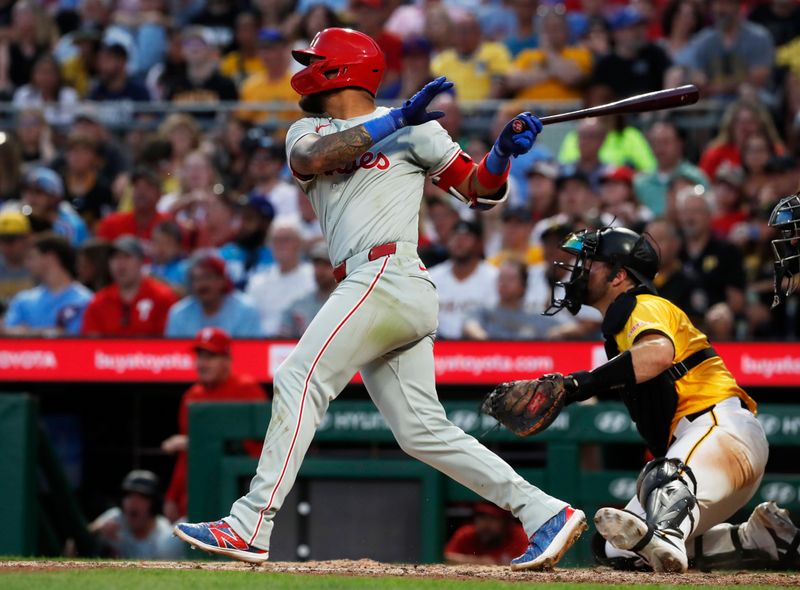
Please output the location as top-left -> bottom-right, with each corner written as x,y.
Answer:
739,502 -> 800,568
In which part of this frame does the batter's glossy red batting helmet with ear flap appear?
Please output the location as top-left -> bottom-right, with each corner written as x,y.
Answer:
292,28 -> 386,96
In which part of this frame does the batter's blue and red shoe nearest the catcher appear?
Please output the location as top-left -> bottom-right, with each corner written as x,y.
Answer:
511,506 -> 588,570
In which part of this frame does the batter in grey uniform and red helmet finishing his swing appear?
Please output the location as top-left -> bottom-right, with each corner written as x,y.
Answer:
175,28 -> 586,569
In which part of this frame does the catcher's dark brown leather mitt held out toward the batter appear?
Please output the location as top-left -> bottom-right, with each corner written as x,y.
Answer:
481,373 -> 567,436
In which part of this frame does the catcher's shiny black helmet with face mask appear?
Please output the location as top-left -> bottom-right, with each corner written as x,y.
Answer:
544,227 -> 659,315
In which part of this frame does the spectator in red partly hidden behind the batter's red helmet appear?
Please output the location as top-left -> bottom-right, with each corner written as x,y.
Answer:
350,0 -> 403,99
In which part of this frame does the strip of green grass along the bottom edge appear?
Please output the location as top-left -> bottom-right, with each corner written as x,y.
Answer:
0,569 -> 788,590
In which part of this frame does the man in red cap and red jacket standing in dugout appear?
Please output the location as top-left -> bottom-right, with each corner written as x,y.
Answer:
161,328 -> 268,524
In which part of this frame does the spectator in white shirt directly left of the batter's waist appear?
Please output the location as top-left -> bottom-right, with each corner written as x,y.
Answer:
246,218 -> 315,337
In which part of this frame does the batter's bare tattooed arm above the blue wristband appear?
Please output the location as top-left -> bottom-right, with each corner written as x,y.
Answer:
292,125 -> 373,174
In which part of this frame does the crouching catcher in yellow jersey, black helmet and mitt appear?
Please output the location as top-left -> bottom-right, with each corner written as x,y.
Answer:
484,228 -> 800,572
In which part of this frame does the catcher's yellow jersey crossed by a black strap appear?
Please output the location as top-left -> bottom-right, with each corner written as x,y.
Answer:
615,295 -> 756,435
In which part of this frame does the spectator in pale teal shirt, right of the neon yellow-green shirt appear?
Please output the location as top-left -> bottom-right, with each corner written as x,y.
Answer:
633,121 -> 708,216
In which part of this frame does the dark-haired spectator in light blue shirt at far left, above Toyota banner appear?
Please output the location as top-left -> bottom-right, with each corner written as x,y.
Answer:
3,233 -> 92,336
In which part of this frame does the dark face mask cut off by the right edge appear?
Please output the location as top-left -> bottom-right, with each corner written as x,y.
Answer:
769,193 -> 800,308
